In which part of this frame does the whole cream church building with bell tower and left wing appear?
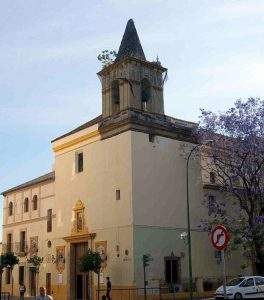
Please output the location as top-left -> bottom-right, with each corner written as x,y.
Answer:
2,20 -> 246,300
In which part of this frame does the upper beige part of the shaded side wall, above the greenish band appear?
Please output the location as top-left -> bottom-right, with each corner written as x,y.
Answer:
132,132 -> 203,228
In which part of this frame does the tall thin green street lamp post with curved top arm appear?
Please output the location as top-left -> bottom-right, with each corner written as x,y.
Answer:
186,141 -> 211,300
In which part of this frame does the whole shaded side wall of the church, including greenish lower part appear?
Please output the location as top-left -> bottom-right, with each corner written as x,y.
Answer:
132,132 -> 249,286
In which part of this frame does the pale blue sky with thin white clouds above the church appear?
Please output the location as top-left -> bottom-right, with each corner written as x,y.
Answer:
0,0 -> 264,232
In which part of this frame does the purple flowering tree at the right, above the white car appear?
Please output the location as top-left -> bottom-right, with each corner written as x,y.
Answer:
198,98 -> 264,275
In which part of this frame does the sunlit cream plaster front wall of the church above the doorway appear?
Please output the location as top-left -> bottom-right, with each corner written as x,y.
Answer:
55,132 -> 133,285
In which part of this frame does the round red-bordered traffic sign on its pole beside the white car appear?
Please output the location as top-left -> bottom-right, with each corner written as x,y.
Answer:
211,225 -> 230,299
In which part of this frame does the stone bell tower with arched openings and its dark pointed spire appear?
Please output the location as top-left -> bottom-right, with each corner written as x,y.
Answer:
98,19 -> 167,118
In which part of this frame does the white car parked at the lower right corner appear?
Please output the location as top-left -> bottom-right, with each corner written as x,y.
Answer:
215,276 -> 264,299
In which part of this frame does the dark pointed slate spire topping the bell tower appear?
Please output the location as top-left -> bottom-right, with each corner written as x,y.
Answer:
115,19 -> 146,61
